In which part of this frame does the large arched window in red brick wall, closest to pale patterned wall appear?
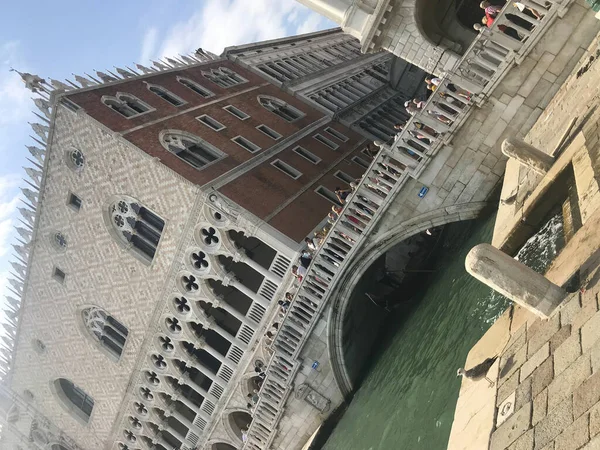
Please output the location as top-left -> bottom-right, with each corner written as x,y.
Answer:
159,131 -> 225,169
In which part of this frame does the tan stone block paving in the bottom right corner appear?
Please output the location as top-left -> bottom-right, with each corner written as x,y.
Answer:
490,278 -> 600,450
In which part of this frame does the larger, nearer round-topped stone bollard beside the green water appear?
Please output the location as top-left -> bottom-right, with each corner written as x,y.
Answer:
465,244 -> 567,319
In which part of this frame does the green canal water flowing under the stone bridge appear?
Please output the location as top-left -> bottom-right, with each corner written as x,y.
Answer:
323,211 -> 561,450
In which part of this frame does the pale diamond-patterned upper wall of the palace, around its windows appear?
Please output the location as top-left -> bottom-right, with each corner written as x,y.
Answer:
11,104 -> 197,448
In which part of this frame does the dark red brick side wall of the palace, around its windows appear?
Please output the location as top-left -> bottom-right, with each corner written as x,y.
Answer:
64,61 -> 363,242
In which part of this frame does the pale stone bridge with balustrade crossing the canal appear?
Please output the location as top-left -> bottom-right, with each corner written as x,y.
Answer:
243,0 -> 600,450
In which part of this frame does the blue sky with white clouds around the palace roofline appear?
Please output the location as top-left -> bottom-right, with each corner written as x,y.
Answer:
0,0 -> 335,326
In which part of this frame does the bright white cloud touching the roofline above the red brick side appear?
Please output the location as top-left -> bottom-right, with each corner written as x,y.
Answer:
142,0 -> 332,61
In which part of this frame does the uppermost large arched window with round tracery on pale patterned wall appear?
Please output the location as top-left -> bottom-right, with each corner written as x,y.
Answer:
108,196 -> 165,264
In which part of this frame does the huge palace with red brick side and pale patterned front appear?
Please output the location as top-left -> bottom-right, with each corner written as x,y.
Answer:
0,30 -> 422,450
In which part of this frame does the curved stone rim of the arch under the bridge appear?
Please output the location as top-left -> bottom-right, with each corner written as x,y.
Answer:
327,202 -> 491,397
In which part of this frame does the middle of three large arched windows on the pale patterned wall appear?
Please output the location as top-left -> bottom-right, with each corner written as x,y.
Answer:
81,306 -> 129,361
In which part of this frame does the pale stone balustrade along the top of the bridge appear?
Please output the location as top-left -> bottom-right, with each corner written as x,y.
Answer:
243,0 -> 568,450
